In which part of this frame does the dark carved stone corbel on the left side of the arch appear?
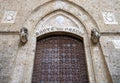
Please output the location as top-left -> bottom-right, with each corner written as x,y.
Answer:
19,27 -> 28,44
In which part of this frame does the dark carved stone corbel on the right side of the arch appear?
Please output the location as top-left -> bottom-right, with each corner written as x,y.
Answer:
91,29 -> 100,44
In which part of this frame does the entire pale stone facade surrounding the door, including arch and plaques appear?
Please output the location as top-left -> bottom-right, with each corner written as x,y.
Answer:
0,0 -> 120,83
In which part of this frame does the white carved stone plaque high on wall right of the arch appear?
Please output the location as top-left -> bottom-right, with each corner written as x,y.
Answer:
102,11 -> 118,24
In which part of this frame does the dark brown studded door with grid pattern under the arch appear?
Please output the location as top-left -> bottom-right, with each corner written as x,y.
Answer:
32,36 -> 88,83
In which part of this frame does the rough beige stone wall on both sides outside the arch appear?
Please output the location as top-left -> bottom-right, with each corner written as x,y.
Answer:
0,0 -> 120,83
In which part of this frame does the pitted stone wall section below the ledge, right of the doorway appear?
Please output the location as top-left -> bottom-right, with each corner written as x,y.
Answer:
100,36 -> 120,83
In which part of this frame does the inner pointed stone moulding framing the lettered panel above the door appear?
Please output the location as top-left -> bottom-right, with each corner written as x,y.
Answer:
33,10 -> 87,38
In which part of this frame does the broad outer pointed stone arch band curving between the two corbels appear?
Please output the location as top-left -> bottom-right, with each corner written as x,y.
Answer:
23,1 -> 99,35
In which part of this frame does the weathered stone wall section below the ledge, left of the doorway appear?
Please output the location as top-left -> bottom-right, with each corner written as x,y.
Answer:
0,35 -> 19,83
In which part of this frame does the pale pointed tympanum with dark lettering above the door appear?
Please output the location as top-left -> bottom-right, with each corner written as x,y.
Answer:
34,10 -> 86,38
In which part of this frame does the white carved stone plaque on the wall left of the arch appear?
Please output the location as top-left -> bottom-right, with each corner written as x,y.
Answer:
1,11 -> 17,23
